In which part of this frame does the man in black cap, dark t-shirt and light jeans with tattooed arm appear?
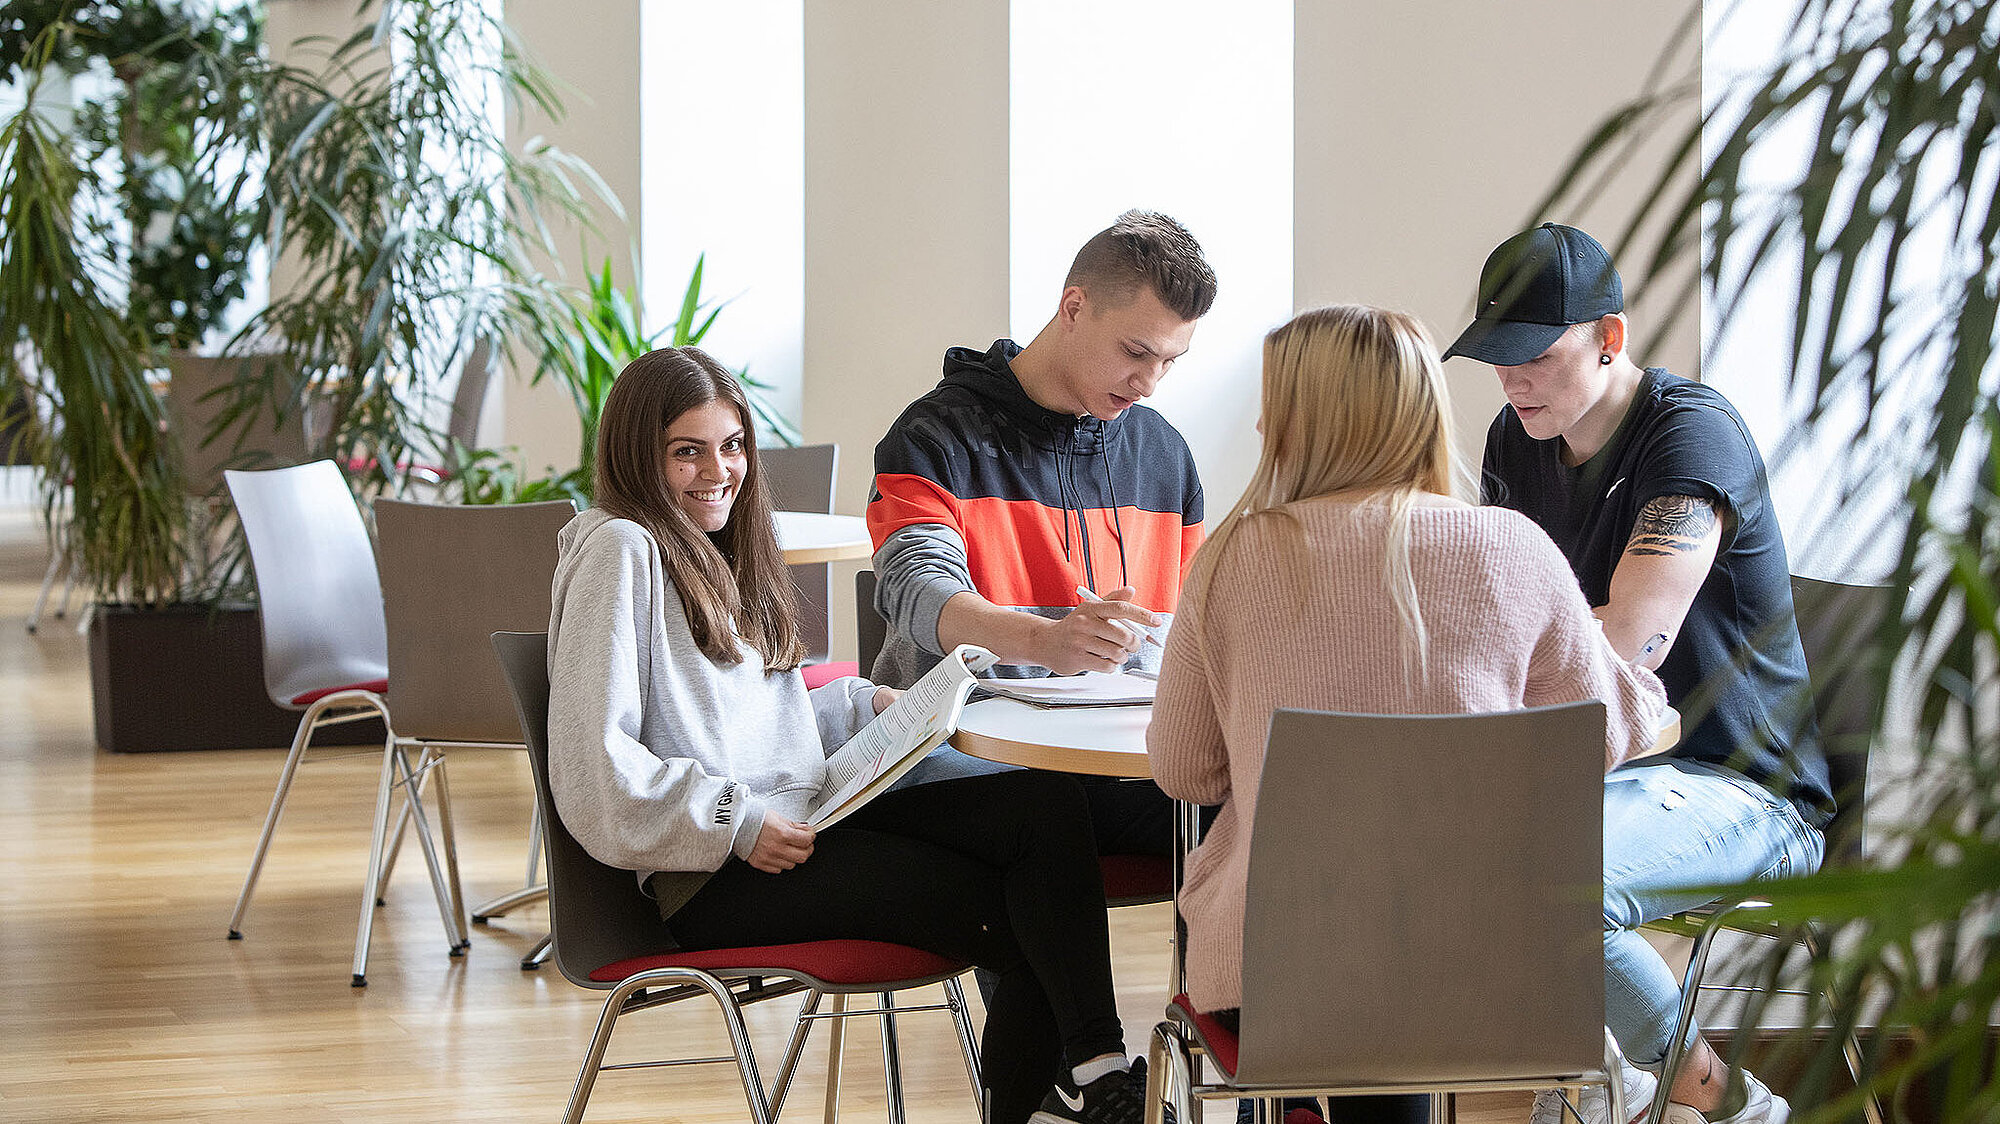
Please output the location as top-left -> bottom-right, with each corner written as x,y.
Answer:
1444,222 -> 1834,1124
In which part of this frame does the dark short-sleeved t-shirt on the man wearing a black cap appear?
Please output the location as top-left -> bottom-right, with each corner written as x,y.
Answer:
1482,368 -> 1834,826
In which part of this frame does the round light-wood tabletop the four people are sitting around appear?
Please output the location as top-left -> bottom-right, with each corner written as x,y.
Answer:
952,698 -> 1680,776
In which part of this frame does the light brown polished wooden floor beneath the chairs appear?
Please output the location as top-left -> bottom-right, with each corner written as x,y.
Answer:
0,506 -> 1526,1124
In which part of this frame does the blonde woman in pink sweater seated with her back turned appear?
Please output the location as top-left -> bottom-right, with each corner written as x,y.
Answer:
1146,306 -> 1666,1122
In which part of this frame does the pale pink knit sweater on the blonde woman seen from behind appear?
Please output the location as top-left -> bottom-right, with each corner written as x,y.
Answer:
1146,498 -> 1666,1010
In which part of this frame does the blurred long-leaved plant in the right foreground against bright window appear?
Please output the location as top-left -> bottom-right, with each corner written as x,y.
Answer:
1540,0 -> 2000,1124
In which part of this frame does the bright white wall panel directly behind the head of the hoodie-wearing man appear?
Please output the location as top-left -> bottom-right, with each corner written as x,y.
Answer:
1016,0 -> 1292,518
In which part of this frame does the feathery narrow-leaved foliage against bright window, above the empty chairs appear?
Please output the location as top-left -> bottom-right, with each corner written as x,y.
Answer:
236,0 -> 616,492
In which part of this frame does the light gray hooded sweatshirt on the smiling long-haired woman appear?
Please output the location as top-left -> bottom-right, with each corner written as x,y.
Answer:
548,508 -> 874,892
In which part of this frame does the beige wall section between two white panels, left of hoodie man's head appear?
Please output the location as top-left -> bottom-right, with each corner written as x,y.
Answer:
804,0 -> 1008,512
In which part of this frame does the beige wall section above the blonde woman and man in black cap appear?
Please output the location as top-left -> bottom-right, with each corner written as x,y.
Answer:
1296,0 -> 1700,466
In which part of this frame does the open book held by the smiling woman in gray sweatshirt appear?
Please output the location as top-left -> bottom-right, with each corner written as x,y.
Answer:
806,644 -> 998,828
